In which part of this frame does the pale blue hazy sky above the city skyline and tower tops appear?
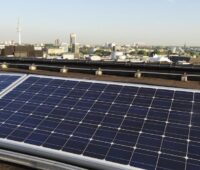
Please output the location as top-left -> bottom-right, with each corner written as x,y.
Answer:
0,0 -> 200,45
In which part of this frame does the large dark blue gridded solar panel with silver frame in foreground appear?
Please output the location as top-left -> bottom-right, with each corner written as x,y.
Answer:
0,76 -> 200,170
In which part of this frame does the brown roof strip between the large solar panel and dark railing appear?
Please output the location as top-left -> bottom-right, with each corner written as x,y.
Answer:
0,68 -> 200,89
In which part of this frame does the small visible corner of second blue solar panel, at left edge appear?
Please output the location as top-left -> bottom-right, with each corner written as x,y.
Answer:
0,74 -> 21,93
